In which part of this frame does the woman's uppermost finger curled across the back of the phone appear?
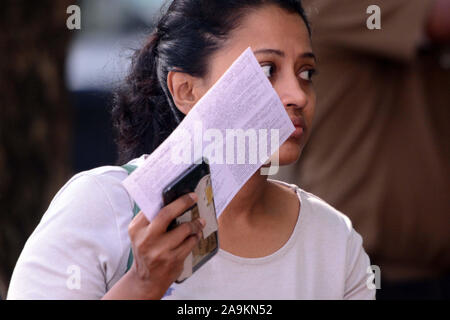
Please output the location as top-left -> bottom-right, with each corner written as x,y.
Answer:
152,192 -> 197,233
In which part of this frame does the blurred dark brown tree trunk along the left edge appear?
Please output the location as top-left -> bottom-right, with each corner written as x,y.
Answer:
0,0 -> 76,299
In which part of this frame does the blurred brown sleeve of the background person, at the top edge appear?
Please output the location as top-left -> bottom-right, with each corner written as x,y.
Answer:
303,0 -> 440,59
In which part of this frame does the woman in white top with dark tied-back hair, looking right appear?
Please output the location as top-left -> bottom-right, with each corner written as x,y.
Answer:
9,0 -> 375,299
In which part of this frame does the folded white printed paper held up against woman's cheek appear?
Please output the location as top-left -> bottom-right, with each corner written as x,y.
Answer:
123,47 -> 295,221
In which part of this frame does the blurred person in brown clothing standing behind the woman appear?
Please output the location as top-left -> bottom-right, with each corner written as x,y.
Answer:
277,0 -> 450,299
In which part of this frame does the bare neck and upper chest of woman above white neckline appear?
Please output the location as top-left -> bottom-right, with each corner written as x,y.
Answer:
218,164 -> 300,258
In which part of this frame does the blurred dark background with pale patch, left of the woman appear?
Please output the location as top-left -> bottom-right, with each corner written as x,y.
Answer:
0,0 -> 163,298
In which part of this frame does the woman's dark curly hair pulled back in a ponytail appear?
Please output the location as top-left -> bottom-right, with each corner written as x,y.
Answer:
112,0 -> 311,165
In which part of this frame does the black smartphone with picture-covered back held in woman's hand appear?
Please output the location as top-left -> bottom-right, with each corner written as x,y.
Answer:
163,158 -> 219,283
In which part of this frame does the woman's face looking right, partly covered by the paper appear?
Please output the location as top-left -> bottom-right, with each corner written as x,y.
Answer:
186,5 -> 316,165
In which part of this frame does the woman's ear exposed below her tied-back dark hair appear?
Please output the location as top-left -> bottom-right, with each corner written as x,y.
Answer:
167,71 -> 200,114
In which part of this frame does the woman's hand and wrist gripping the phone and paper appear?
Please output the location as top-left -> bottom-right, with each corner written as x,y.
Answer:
103,193 -> 205,299
